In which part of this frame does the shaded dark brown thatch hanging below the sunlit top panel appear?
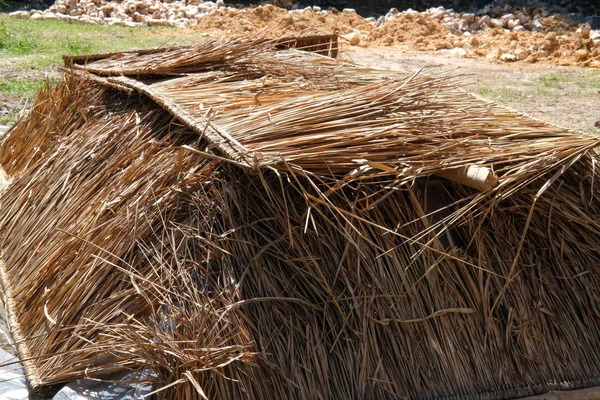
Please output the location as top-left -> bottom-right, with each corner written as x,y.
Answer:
103,158 -> 600,399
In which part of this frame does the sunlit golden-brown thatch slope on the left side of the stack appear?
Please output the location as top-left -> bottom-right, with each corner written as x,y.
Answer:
0,76 -> 213,386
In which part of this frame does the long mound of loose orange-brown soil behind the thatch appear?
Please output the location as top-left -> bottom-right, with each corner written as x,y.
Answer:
195,5 -> 600,68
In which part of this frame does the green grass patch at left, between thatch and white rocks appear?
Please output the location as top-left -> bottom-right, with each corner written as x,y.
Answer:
0,16 -> 204,119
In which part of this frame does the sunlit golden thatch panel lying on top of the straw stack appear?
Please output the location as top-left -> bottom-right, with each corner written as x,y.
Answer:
110,50 -> 600,198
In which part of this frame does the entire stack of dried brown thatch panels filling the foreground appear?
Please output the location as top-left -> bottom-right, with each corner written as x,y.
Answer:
0,36 -> 600,399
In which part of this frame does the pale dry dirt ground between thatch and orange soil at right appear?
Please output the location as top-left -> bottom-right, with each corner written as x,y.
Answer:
346,47 -> 600,134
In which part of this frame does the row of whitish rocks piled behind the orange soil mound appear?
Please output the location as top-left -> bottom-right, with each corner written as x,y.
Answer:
10,0 -> 600,45
